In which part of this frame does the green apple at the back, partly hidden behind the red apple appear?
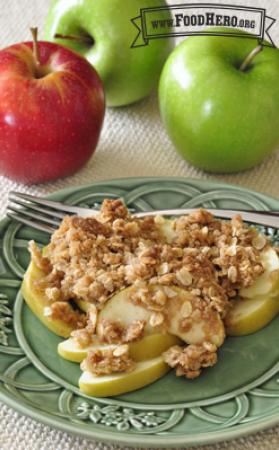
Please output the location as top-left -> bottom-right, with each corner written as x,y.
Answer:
45,0 -> 172,106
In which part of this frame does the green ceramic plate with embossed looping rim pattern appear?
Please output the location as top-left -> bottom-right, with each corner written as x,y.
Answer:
0,178 -> 279,448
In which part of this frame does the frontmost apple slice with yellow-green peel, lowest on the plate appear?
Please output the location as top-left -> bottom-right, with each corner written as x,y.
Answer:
79,356 -> 170,397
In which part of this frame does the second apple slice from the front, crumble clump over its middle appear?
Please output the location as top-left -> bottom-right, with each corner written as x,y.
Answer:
57,333 -> 181,362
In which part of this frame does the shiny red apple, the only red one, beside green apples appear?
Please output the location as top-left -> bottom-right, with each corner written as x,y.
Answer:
0,42 -> 105,184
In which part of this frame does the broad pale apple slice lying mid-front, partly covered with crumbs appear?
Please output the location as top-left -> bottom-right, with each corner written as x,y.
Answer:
97,286 -> 225,346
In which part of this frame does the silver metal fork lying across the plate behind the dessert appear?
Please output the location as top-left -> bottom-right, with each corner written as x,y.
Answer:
7,192 -> 279,234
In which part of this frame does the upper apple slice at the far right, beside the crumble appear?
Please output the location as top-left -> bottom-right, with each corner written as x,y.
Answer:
239,248 -> 279,298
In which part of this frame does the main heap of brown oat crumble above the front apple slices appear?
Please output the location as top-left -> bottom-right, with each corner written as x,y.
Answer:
30,200 -> 268,313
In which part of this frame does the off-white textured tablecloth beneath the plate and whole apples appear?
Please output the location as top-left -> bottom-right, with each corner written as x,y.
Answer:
0,0 -> 279,450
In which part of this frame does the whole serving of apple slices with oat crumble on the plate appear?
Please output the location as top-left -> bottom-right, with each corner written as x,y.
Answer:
22,200 -> 279,396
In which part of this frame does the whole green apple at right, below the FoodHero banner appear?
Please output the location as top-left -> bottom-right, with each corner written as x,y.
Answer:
159,36 -> 279,173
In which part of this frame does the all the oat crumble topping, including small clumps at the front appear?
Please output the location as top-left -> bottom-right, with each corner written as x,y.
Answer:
26,200 -> 274,378
